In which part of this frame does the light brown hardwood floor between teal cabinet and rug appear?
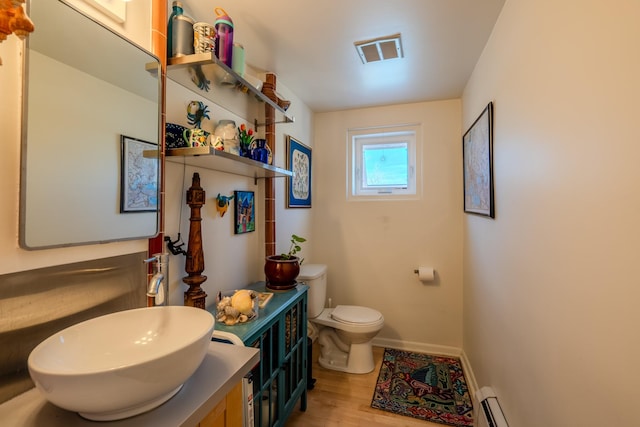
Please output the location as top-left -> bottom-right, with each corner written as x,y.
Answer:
286,343 -> 442,427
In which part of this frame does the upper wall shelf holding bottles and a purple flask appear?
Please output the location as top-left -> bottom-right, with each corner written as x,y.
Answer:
167,52 -> 295,126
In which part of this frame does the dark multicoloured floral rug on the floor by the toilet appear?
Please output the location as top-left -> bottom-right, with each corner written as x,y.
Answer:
371,348 -> 473,427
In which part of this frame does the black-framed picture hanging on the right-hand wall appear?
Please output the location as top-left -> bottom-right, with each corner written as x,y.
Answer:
462,102 -> 495,218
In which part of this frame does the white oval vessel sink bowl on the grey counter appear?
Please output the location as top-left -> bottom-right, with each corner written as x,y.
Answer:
28,306 -> 215,421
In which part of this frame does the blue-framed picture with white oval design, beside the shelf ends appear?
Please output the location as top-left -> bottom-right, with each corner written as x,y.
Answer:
287,135 -> 311,208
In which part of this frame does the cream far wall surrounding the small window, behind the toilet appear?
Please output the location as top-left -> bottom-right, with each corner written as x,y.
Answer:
307,100 -> 462,351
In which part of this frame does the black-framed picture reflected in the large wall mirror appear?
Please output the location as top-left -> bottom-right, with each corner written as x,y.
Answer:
120,135 -> 159,213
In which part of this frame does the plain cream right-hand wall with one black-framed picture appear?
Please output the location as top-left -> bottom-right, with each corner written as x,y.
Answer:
463,0 -> 640,427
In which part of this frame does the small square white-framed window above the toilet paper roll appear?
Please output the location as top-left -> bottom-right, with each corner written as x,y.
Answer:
347,125 -> 422,200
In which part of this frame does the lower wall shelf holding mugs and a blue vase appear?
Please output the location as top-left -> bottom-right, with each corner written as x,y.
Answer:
166,147 -> 293,180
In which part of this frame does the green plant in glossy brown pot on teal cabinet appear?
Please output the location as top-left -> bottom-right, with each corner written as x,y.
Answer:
264,234 -> 307,291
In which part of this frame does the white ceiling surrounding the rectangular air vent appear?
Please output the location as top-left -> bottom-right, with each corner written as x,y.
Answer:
183,0 -> 504,112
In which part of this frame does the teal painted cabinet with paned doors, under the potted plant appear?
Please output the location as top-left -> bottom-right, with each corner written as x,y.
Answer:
211,282 -> 309,427
